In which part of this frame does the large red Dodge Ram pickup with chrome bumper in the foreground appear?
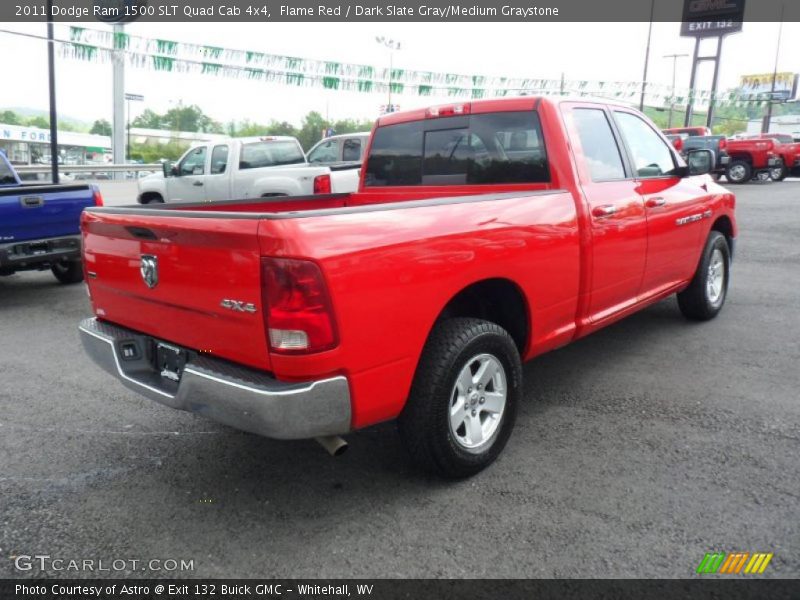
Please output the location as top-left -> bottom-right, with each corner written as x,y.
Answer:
80,97 -> 736,477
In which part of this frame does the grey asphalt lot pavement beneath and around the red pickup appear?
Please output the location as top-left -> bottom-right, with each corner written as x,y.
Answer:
0,181 -> 800,578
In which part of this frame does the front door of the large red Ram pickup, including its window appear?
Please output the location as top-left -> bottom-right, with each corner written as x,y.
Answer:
613,108 -> 711,296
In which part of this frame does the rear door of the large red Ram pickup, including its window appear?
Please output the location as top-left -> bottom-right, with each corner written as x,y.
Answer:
563,104 -> 647,321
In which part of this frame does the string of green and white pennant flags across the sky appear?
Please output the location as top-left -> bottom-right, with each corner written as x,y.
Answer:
60,26 -> 761,106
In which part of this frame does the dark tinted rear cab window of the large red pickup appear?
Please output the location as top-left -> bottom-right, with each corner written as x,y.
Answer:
365,111 -> 550,187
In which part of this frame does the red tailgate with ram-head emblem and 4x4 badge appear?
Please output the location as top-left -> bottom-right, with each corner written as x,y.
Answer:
82,210 -> 269,369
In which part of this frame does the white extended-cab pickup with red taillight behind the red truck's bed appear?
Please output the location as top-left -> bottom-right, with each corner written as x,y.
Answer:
138,136 -> 360,204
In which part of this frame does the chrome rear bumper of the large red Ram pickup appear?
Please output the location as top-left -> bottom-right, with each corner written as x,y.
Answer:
78,319 -> 351,439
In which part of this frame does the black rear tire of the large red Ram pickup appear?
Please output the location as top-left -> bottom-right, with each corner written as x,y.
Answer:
398,318 -> 522,479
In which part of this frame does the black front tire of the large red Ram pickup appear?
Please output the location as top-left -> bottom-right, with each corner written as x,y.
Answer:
678,231 -> 731,321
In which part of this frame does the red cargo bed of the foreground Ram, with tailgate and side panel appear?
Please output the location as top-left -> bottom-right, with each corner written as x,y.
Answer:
83,189 -> 580,422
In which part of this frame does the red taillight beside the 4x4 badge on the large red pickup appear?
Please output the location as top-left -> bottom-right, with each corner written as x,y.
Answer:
261,258 -> 338,354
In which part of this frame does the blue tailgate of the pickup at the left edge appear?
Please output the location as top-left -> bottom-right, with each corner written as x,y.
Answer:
0,185 -> 94,242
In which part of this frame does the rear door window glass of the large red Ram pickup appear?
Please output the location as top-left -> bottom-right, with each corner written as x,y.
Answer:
572,108 -> 625,181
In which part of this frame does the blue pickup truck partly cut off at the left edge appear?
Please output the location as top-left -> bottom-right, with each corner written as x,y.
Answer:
0,152 -> 103,283
